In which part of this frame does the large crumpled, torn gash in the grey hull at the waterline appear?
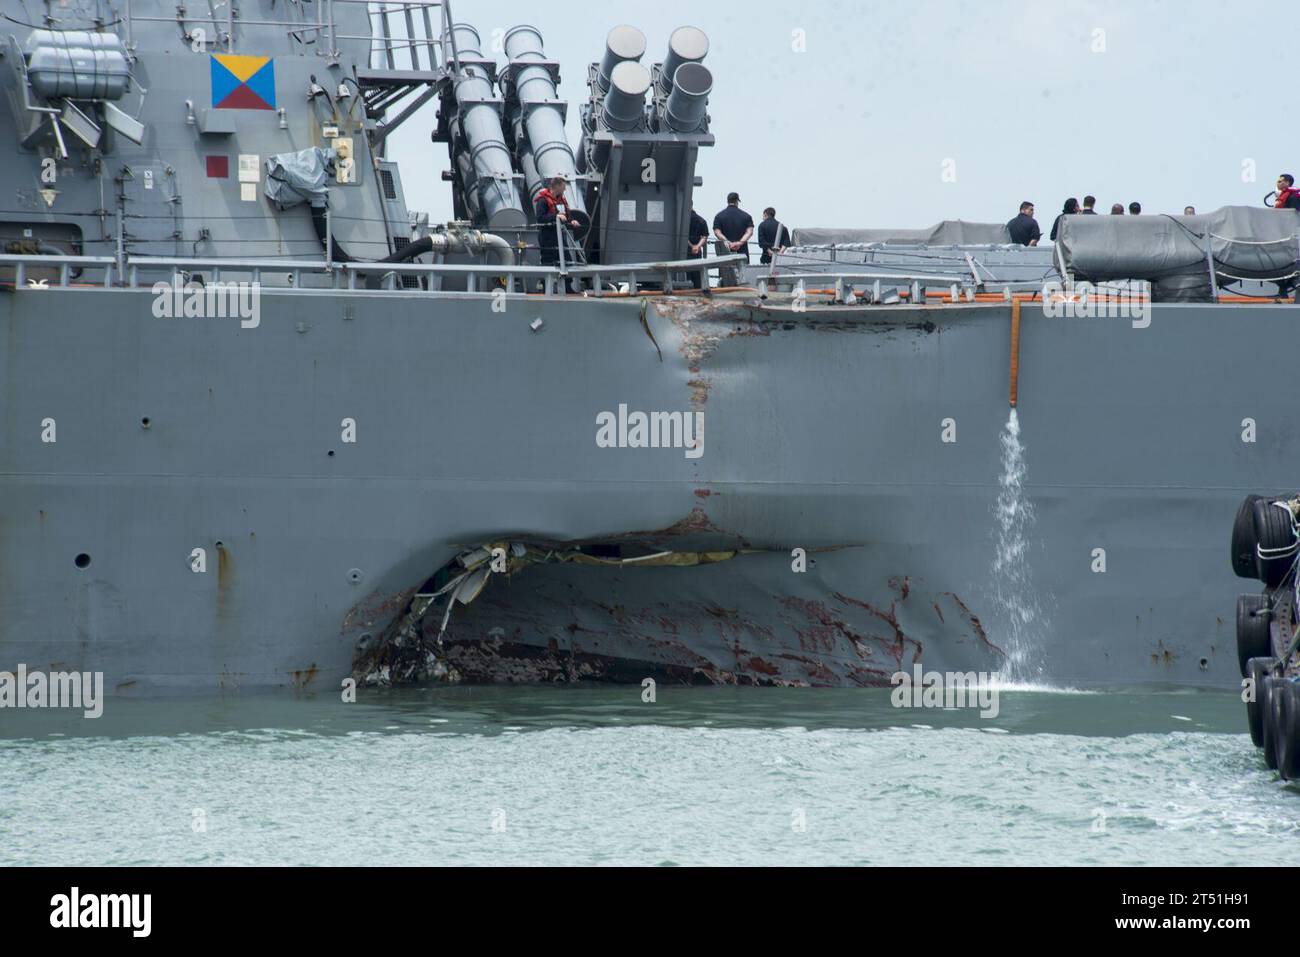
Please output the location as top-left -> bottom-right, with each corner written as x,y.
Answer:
354,536 -> 1005,687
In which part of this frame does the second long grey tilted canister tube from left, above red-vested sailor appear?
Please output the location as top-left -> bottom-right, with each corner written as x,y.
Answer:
506,25 -> 585,212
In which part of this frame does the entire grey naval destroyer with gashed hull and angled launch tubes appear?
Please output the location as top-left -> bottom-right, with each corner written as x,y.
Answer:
0,0 -> 1300,694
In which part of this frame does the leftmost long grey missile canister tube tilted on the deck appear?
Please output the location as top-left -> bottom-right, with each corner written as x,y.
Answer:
449,23 -> 528,229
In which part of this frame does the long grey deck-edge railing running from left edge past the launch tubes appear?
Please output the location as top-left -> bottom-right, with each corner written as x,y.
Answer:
0,254 -> 745,295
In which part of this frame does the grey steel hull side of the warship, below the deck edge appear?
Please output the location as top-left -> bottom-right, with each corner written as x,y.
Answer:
0,289 -> 1300,693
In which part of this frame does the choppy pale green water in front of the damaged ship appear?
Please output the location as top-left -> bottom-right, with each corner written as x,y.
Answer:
0,688 -> 1300,865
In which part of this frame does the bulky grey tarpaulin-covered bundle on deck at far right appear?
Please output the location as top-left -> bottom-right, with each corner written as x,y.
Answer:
1057,205 -> 1300,299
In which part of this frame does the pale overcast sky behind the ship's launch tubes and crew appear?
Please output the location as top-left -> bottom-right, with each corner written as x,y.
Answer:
390,0 -> 1300,228
